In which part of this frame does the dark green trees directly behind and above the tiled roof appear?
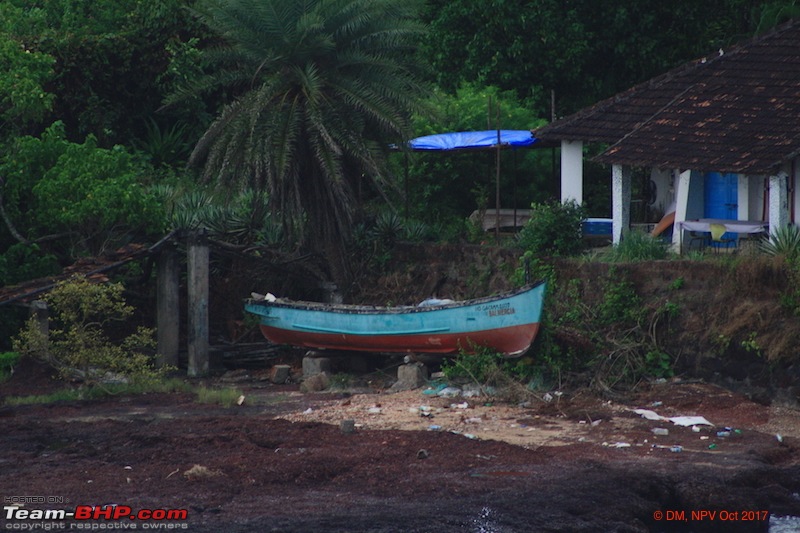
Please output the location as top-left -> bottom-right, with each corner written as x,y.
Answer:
424,0 -> 760,117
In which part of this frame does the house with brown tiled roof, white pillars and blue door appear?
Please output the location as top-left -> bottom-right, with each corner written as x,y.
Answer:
534,20 -> 800,246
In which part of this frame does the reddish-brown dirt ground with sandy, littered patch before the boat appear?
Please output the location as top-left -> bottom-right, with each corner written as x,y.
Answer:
0,358 -> 800,533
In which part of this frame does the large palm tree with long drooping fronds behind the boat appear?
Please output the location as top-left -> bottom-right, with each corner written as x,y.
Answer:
190,0 -> 427,282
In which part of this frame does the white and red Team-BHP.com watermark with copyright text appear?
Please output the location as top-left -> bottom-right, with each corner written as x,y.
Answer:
2,496 -> 189,531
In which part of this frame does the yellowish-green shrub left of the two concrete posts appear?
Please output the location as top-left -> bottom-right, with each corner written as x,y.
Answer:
14,277 -> 164,385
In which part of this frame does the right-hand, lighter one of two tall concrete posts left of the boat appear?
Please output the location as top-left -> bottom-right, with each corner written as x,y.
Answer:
187,229 -> 209,377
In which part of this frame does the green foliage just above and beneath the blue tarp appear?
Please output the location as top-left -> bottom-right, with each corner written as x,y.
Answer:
394,84 -> 552,223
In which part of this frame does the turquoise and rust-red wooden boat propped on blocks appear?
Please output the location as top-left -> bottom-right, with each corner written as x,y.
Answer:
245,281 -> 545,356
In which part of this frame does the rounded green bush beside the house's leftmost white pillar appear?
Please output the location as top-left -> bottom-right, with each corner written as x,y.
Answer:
518,201 -> 586,256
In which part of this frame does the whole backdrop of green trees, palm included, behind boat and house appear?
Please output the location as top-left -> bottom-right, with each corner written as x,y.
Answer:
0,0 -> 800,283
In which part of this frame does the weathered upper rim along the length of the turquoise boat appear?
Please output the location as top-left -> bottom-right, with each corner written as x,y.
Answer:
245,280 -> 546,314
